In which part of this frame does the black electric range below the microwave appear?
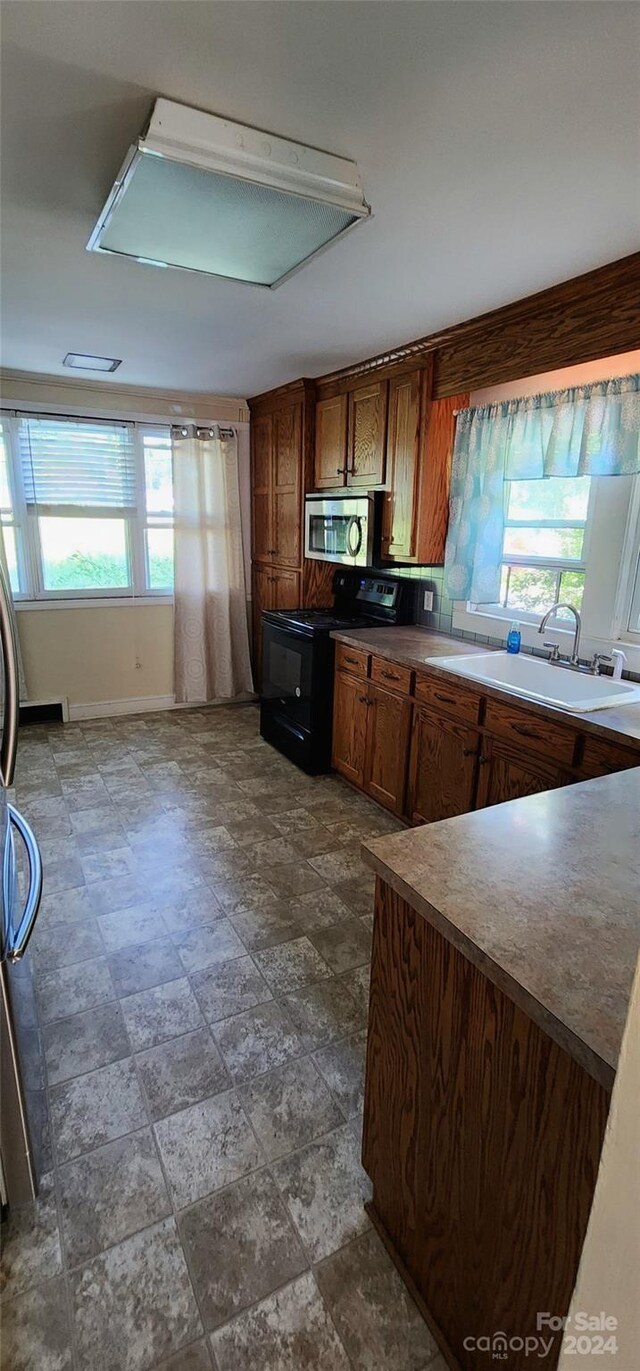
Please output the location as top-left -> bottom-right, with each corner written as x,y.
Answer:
260,569 -> 411,775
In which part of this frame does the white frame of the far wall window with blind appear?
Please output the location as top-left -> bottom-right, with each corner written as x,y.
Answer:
1,410 -> 174,610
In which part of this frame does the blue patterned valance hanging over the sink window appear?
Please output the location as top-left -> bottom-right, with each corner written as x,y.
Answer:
444,374 -> 640,605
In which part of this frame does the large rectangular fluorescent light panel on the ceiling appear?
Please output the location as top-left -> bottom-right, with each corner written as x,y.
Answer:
88,99 -> 371,288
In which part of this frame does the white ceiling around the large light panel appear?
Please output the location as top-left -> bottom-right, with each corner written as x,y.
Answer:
1,0 -> 640,395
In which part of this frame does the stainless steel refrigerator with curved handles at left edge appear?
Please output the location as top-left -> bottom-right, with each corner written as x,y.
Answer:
0,566 -> 44,1209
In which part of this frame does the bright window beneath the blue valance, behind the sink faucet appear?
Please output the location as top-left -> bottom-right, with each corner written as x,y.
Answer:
500,476 -> 592,618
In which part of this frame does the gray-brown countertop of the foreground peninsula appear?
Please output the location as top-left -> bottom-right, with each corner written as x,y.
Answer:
362,768 -> 640,1089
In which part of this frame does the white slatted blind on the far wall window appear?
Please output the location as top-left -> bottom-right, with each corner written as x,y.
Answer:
18,414 -> 137,511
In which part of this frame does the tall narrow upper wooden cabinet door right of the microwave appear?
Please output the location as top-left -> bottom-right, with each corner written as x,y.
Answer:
382,372 -> 421,559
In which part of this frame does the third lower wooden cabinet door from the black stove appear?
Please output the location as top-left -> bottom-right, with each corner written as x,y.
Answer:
407,707 -> 480,824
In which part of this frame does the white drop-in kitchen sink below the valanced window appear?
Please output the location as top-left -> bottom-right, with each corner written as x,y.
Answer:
428,653 -> 640,713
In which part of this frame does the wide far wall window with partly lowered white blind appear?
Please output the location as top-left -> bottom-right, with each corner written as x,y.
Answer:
0,415 -> 173,599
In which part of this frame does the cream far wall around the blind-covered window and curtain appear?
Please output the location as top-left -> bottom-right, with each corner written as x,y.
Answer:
0,372 -> 251,718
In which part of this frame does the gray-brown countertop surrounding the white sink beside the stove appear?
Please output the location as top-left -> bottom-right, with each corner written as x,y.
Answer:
332,627 -> 640,747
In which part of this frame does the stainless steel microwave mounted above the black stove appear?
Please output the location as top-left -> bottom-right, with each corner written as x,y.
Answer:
304,494 -> 377,566
